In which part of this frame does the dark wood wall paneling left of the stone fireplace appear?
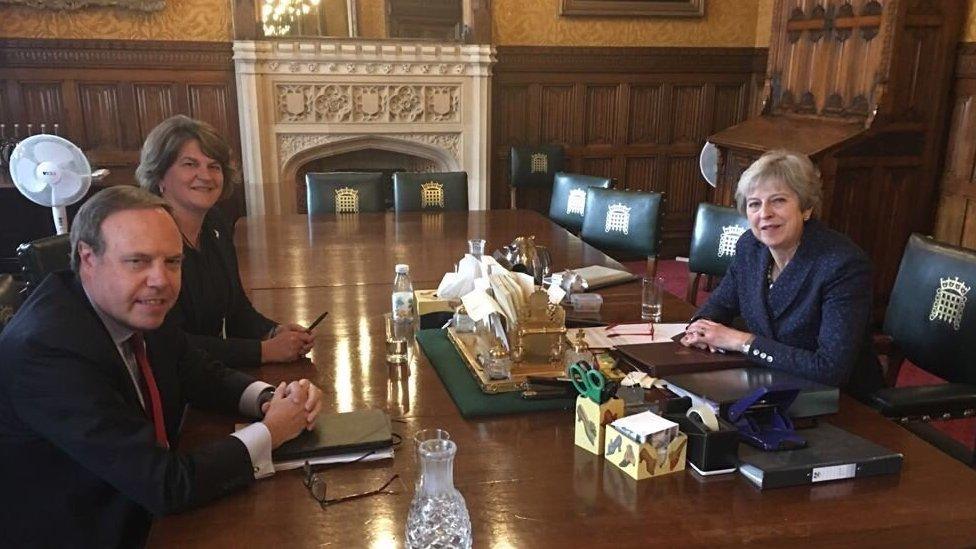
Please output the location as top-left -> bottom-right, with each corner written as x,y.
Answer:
0,39 -> 244,266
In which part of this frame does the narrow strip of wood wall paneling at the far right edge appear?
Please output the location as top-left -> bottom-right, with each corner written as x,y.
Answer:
934,43 -> 976,249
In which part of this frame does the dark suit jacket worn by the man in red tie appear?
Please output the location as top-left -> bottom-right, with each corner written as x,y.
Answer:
0,271 -> 254,547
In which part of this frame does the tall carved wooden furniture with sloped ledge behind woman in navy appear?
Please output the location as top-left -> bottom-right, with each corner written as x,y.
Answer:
713,0 -> 964,320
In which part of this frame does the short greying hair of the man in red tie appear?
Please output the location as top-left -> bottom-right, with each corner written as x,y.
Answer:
71,185 -> 173,273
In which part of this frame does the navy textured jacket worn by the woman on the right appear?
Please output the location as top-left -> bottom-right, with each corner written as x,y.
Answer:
697,221 -> 881,394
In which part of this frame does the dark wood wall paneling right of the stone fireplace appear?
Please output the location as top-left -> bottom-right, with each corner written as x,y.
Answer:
490,47 -> 766,256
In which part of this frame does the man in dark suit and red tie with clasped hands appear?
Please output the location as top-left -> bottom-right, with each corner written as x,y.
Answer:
0,187 -> 321,547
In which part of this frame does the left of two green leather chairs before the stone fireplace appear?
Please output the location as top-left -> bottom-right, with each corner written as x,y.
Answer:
305,172 -> 386,215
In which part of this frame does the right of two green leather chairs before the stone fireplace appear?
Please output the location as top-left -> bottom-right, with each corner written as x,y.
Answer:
393,172 -> 468,212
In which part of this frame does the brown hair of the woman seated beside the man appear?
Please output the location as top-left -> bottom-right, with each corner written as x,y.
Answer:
136,114 -> 239,199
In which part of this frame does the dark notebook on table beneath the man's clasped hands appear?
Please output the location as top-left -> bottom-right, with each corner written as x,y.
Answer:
272,409 -> 393,462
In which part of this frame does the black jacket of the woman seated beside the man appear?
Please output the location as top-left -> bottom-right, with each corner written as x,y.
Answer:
170,209 -> 275,368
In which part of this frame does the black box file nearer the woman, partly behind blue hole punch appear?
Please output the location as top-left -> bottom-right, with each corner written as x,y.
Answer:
664,366 -> 840,417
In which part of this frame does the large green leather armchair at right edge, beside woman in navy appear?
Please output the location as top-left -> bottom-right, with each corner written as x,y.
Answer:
872,234 -> 976,466
